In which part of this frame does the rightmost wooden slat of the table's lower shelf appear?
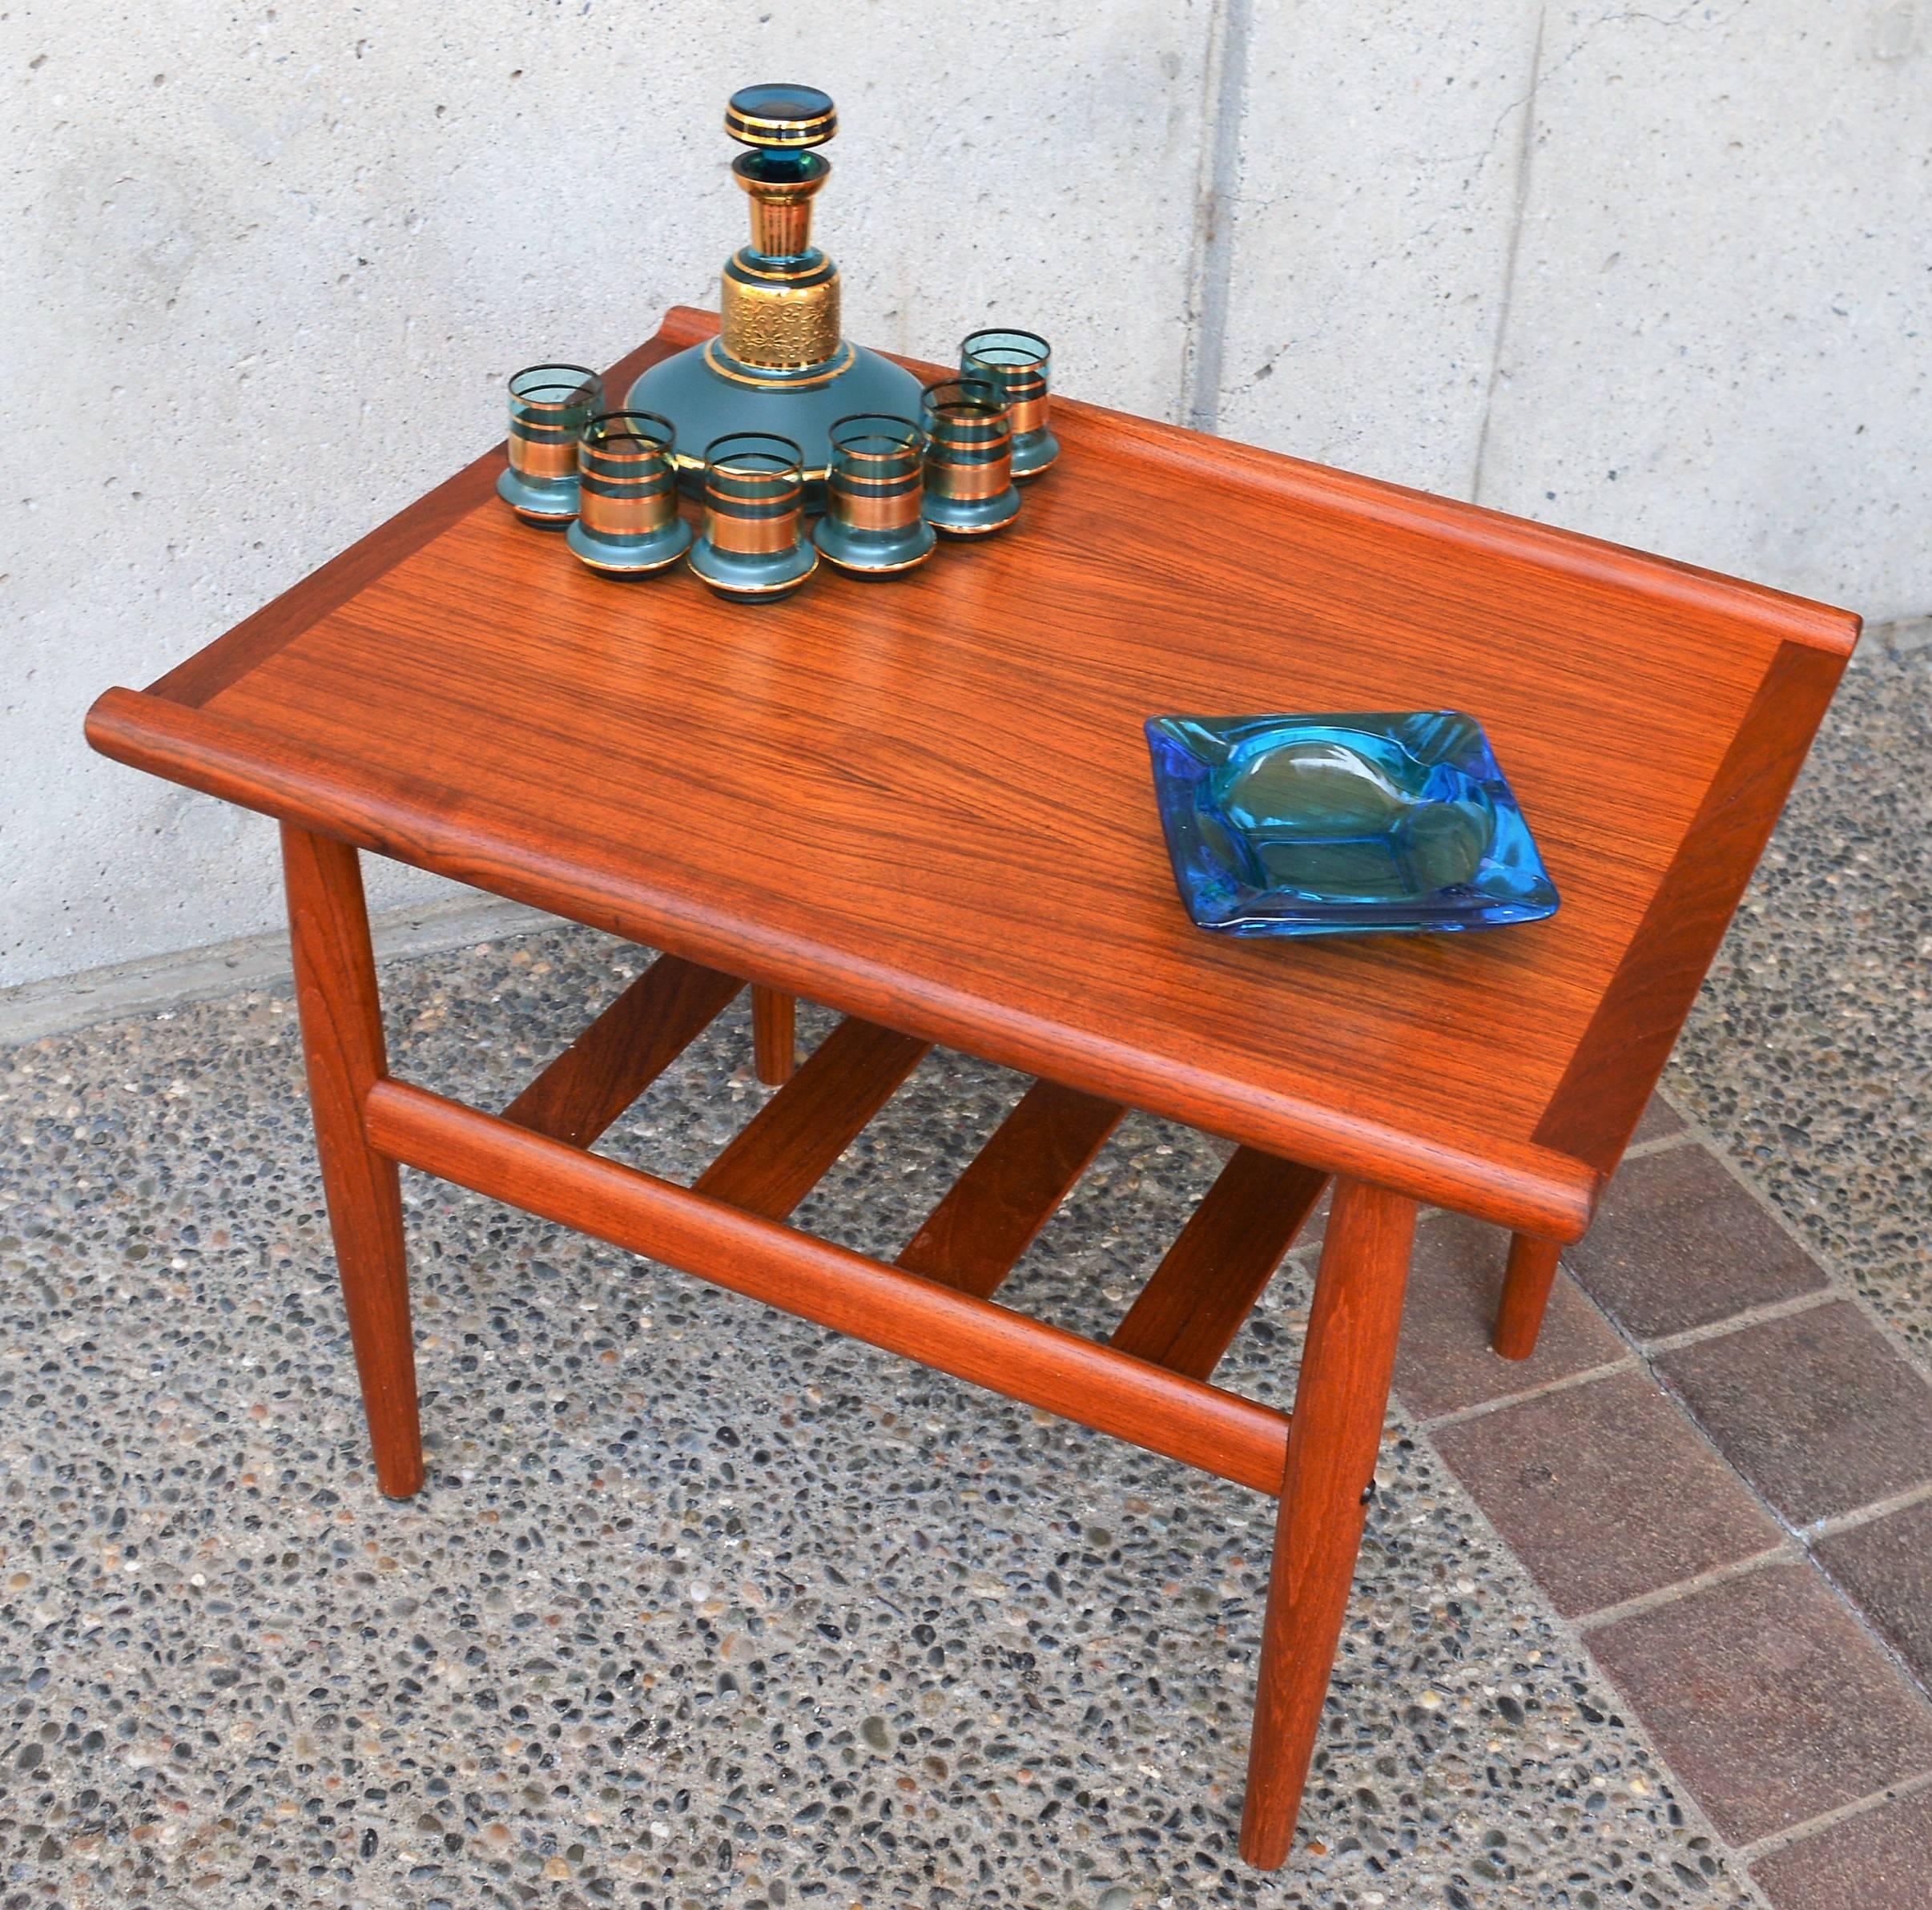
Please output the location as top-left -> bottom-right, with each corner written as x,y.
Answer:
1113,1146 -> 1327,1380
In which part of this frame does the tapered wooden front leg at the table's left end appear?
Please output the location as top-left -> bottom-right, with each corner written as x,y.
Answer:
282,822 -> 423,1498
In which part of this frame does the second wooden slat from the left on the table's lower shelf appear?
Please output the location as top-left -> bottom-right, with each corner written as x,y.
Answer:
694,1019 -> 932,1220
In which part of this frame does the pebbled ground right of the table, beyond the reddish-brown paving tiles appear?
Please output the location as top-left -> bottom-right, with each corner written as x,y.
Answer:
1665,631 -> 1932,1363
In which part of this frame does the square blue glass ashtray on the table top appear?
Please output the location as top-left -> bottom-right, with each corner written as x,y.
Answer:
1148,710 -> 1557,936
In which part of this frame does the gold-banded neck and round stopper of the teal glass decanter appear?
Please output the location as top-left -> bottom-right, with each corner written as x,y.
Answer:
721,85 -> 839,371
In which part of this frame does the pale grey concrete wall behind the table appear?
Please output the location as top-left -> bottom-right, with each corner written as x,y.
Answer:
0,0 -> 1932,984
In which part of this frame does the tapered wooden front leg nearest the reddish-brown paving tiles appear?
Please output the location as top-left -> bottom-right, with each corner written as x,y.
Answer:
1241,1181 -> 1416,1869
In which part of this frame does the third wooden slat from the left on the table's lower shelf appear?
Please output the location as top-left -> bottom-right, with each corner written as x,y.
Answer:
899,1081 -> 1126,1300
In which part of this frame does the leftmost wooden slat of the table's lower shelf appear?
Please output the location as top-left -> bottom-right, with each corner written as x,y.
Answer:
502,955 -> 744,1146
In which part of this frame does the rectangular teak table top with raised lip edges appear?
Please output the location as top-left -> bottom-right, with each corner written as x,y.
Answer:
89,311 -> 1858,1237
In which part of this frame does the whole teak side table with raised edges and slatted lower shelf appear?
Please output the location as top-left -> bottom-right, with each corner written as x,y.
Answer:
87,309 -> 1858,1868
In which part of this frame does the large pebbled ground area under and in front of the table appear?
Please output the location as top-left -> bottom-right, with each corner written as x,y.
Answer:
0,930 -> 1757,1910
